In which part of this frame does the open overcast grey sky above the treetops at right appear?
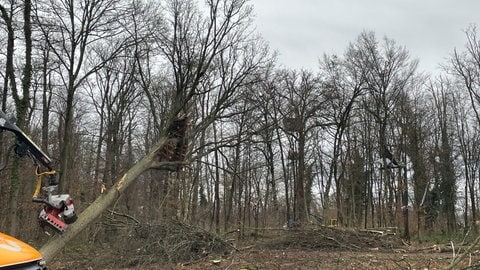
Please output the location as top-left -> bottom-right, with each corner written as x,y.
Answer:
251,0 -> 480,73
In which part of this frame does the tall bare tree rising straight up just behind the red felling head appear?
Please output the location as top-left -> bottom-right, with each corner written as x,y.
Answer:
34,0 -> 130,186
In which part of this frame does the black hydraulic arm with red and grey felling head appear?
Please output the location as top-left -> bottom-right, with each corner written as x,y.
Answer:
0,111 -> 77,233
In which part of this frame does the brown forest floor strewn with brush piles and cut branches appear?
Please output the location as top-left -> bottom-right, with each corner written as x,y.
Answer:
49,220 -> 480,270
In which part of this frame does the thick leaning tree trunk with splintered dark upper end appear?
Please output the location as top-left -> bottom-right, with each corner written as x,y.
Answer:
40,118 -> 188,261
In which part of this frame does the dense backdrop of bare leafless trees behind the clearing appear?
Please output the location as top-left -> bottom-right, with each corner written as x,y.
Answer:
0,0 -> 480,243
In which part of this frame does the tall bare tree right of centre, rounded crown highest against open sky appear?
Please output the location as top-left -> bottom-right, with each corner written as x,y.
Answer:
357,32 -> 418,230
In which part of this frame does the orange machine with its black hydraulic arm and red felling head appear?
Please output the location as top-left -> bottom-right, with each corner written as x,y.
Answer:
0,110 -> 77,270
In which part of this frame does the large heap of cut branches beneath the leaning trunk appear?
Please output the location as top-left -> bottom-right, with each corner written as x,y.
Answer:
51,215 -> 234,269
